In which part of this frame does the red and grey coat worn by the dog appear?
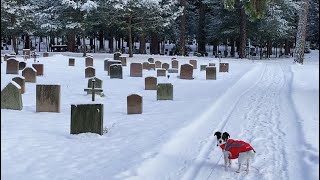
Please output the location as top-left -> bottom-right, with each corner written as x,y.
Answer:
220,139 -> 254,159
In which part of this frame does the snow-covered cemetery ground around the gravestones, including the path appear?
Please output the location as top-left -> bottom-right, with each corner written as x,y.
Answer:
1,51 -> 319,180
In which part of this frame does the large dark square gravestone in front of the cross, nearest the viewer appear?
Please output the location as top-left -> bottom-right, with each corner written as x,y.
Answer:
70,104 -> 103,135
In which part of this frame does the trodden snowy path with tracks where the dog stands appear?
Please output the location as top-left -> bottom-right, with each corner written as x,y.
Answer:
124,63 -> 304,180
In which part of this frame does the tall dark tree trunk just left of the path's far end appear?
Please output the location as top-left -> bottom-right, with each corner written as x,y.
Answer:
239,1 -> 247,59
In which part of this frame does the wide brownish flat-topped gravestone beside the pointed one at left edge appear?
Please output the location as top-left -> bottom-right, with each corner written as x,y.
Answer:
36,84 -> 60,113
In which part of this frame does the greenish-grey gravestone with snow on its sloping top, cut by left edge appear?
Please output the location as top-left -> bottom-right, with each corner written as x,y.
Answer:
1,81 -> 23,110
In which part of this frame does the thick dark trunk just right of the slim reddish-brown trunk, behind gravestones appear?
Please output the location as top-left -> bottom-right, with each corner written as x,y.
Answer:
197,1 -> 206,55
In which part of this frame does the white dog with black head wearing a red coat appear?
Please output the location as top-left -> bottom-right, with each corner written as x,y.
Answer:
214,131 -> 256,173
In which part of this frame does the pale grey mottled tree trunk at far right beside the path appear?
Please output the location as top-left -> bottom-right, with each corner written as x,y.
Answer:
294,0 -> 309,64
